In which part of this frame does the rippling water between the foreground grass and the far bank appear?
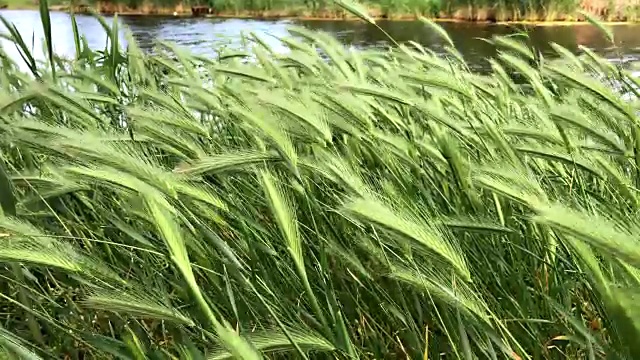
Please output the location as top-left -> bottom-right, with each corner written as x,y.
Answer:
0,10 -> 640,69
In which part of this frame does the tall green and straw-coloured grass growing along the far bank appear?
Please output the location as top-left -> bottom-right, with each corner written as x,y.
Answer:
53,0 -> 640,22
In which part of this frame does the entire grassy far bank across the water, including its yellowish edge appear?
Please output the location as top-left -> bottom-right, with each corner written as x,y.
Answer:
0,0 -> 640,25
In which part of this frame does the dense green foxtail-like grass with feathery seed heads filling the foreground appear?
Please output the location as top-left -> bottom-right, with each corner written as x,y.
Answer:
0,5 -> 640,359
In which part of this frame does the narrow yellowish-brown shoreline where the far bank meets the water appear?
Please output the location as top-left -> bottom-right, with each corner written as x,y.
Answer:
0,5 -> 640,26
